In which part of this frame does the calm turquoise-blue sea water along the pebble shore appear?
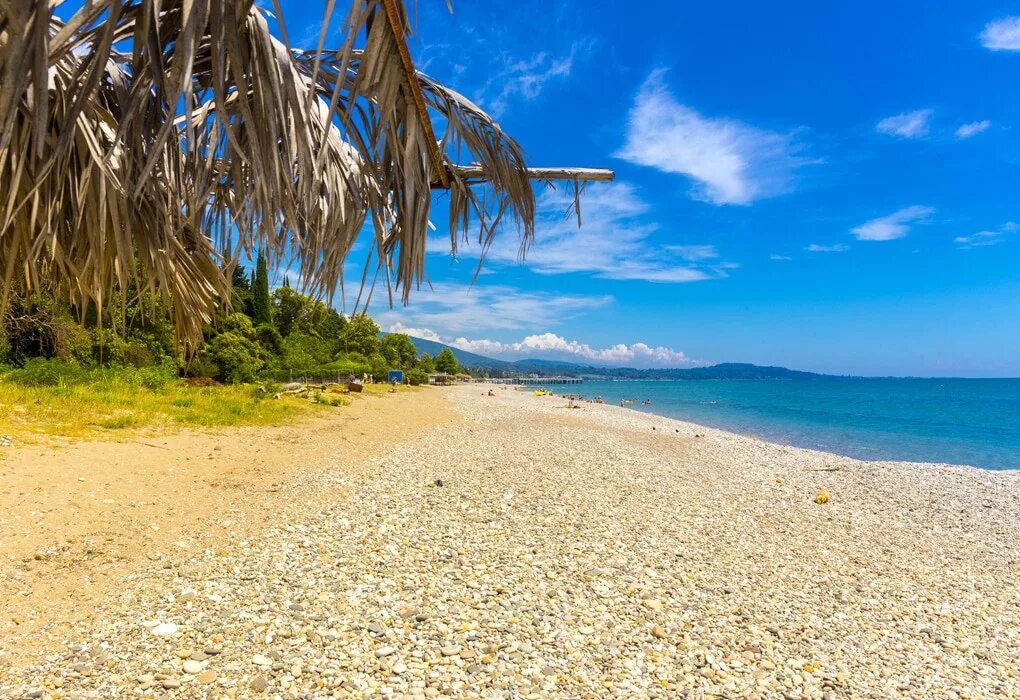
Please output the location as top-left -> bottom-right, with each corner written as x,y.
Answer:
575,378 -> 1020,469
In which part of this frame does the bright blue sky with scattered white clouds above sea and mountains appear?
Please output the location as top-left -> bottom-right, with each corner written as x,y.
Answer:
297,5 -> 1020,377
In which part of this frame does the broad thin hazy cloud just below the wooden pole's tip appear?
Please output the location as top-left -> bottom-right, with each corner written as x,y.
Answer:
432,183 -> 734,283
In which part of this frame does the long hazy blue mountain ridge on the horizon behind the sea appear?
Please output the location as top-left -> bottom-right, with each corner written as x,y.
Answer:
391,337 -> 824,380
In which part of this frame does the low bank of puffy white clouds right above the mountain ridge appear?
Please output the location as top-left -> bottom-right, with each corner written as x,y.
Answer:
390,322 -> 705,367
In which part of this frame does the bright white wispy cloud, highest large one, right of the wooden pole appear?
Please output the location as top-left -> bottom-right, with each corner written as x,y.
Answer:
616,70 -> 807,204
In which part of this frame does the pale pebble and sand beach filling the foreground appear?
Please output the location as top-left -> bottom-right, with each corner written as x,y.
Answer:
0,385 -> 1020,700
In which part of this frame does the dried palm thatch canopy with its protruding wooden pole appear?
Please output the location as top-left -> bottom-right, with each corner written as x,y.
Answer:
0,0 -> 612,342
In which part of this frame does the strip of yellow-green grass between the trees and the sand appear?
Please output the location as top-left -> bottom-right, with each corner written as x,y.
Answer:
0,371 -> 326,437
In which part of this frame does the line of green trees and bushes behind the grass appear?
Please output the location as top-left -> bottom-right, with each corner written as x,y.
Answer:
0,254 -> 461,384
